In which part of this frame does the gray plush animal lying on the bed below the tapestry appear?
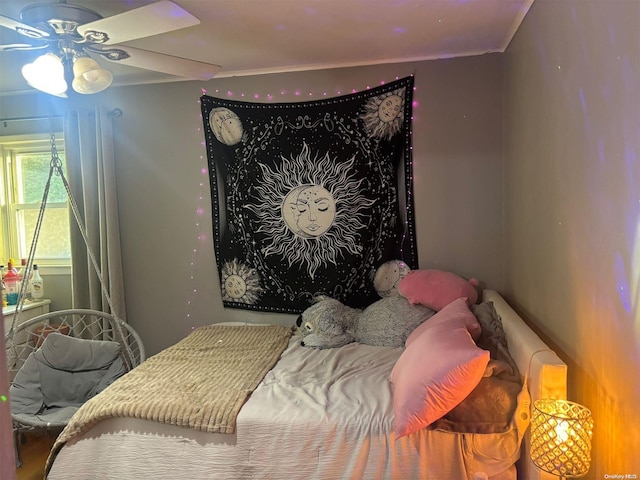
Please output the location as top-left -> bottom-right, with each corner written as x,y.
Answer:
296,296 -> 436,348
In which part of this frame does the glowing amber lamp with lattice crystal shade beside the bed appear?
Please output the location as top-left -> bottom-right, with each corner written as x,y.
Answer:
530,399 -> 593,478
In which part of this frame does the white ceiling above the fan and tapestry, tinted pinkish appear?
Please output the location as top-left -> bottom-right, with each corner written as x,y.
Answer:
0,0 -> 533,95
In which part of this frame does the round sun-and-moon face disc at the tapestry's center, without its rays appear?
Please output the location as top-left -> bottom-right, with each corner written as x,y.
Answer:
281,184 -> 336,238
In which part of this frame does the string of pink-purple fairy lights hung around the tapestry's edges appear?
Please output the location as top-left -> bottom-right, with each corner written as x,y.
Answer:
185,76 -> 417,330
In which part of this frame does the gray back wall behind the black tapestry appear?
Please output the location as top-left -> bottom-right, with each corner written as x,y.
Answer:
0,54 -> 503,354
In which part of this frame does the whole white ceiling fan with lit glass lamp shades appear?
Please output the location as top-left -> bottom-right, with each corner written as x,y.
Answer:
0,0 -> 221,96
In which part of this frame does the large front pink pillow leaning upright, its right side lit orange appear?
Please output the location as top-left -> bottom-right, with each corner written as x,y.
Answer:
391,315 -> 489,438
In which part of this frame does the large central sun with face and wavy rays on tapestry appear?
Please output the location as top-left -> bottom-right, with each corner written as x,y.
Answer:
245,144 -> 373,279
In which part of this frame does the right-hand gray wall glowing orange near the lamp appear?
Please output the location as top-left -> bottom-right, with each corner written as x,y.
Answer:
504,0 -> 640,472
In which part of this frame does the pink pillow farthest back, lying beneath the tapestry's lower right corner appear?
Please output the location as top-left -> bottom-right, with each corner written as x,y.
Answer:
398,270 -> 478,311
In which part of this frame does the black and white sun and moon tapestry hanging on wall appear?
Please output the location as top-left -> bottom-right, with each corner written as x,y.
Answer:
200,76 -> 418,313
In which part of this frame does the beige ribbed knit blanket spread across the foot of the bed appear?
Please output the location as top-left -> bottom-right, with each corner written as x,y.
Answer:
47,325 -> 292,471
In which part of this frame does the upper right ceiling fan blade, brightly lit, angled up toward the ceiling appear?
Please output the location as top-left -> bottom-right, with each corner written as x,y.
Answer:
78,0 -> 200,45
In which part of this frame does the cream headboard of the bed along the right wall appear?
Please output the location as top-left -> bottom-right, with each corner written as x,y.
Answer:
483,290 -> 567,480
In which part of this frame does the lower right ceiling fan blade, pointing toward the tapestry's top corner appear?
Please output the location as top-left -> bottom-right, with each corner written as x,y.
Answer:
97,45 -> 222,80
